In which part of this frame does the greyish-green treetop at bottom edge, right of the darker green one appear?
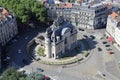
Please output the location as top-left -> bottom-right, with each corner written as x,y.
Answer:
26,72 -> 45,80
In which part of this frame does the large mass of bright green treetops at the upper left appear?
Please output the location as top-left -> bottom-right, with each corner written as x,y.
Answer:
0,0 -> 47,23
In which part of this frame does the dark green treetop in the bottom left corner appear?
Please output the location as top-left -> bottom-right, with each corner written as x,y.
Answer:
0,68 -> 26,80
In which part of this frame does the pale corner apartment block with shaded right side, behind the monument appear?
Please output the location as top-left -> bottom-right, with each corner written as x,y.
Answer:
71,3 -> 107,29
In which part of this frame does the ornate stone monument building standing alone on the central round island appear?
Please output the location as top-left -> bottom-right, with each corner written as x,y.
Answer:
36,17 -> 77,59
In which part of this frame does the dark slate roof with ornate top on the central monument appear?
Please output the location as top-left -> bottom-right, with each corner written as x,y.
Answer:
46,17 -> 75,42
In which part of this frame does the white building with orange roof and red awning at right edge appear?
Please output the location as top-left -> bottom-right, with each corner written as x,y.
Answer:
106,12 -> 120,47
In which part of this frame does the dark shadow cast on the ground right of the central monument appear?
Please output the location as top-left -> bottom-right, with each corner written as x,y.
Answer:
62,37 -> 97,58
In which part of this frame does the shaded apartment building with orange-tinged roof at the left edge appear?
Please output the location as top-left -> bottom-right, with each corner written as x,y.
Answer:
0,7 -> 18,46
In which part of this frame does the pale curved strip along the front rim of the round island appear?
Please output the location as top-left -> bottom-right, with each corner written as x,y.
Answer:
39,52 -> 90,65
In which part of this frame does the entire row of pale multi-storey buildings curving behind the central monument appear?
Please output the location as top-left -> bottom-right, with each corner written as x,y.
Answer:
46,2 -> 107,29
